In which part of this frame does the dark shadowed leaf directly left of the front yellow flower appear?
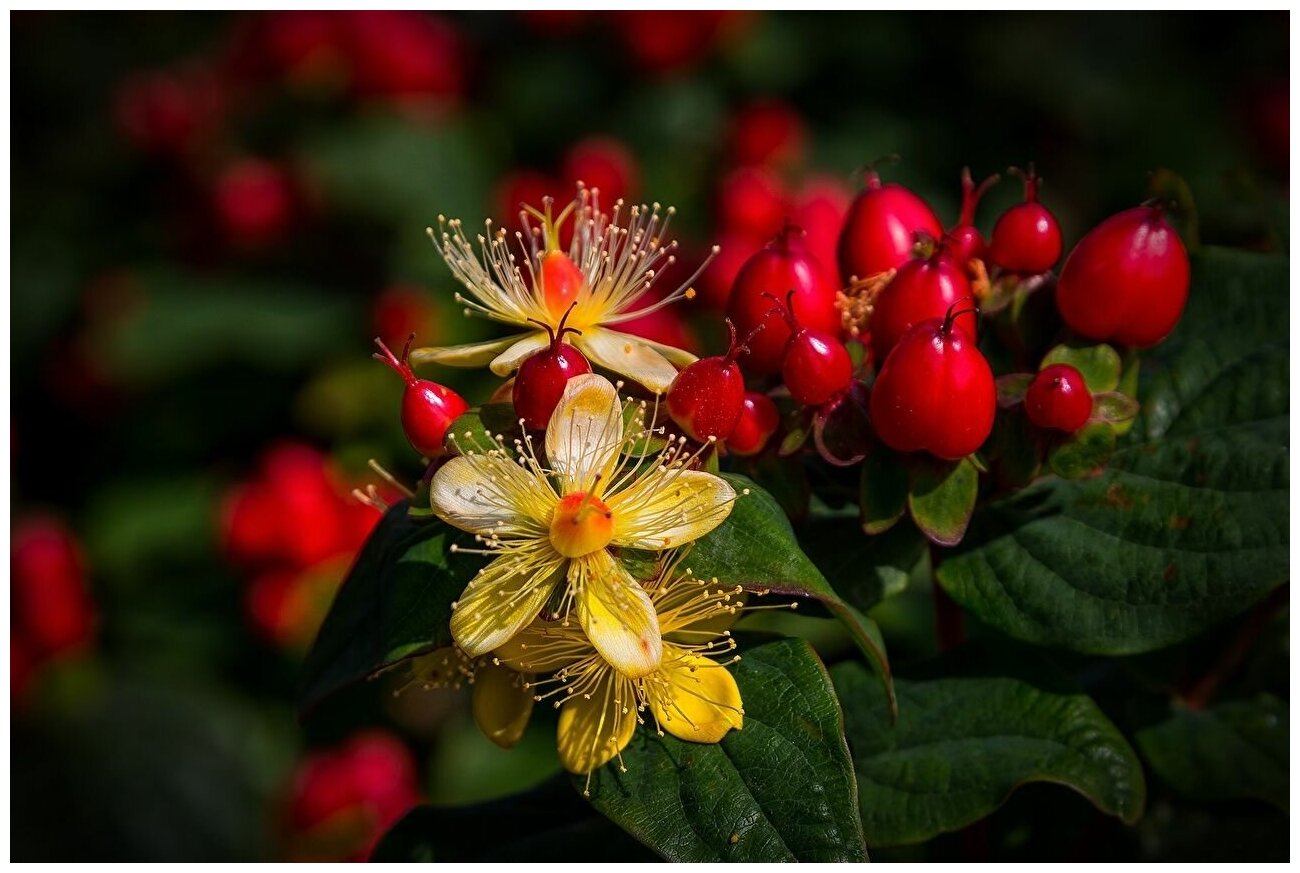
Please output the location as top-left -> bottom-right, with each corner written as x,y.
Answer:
300,503 -> 470,709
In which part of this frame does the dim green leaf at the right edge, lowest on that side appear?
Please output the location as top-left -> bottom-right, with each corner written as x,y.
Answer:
1136,694 -> 1291,811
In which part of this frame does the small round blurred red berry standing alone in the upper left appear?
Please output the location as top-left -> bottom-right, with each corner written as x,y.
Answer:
213,158 -> 294,247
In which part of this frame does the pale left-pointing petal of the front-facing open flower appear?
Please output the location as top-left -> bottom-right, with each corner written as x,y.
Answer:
429,452 -> 556,538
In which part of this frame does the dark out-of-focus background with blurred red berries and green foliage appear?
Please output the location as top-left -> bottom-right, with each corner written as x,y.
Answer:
9,12 -> 1290,860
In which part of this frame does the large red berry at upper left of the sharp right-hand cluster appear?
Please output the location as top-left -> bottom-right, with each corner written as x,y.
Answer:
727,225 -> 840,375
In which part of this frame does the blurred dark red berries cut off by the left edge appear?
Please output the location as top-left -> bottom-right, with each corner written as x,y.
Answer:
9,516 -> 95,699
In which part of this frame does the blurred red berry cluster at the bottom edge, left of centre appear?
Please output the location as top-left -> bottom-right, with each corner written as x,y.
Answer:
282,730 -> 420,861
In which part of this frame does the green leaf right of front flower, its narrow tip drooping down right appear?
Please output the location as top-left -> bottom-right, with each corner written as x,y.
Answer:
686,473 -> 892,717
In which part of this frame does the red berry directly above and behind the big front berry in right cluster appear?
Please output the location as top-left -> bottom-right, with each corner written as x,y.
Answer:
870,247 -> 976,362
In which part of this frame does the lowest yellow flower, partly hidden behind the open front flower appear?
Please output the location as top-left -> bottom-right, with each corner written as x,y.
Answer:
497,563 -> 745,782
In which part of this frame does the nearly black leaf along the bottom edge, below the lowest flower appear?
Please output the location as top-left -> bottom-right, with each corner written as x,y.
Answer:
371,776 -> 657,863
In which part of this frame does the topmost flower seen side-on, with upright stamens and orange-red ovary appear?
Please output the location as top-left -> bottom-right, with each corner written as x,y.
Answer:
411,188 -> 707,394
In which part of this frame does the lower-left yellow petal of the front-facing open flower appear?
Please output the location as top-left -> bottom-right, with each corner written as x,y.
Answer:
451,543 -> 564,657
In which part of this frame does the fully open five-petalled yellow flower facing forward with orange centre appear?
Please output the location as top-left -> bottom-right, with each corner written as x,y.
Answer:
429,374 -> 736,678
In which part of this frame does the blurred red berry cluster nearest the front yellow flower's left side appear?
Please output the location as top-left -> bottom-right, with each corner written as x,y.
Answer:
221,444 -> 380,650
